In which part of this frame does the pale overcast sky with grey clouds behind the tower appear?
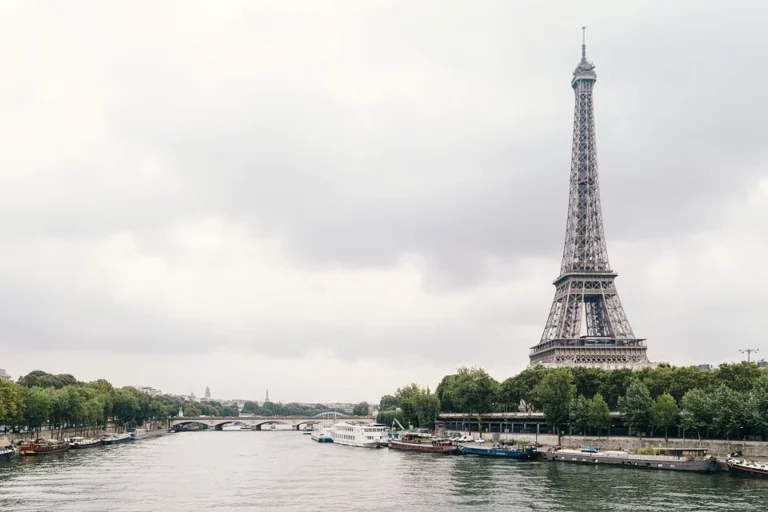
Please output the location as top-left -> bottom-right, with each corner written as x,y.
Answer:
0,0 -> 768,401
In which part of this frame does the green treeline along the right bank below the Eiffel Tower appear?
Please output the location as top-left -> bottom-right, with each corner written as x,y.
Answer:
379,363 -> 768,438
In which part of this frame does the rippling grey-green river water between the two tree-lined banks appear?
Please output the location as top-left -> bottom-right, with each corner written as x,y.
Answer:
0,431 -> 768,512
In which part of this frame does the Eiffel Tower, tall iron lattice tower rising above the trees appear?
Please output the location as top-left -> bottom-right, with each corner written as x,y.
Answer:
530,31 -> 650,368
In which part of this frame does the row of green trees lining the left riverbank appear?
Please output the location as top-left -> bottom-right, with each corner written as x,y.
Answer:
0,370 -> 182,437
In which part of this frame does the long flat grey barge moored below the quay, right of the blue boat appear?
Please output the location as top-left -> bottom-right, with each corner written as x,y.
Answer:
543,446 -> 717,472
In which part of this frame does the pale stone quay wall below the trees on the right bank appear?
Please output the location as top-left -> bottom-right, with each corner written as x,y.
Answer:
440,432 -> 768,458
